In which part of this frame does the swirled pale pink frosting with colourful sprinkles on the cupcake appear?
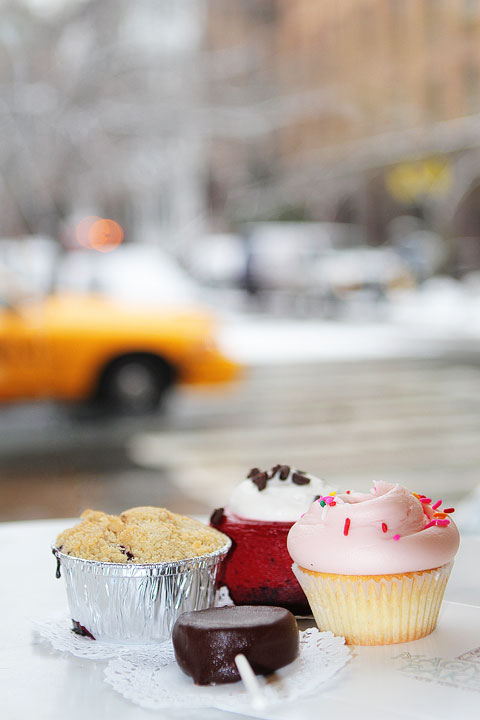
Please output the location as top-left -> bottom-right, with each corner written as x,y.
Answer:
287,482 -> 460,575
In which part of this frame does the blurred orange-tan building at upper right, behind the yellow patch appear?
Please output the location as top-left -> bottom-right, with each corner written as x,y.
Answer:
279,0 -> 480,266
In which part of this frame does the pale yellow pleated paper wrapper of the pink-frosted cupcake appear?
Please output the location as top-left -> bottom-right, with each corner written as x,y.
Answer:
292,562 -> 453,645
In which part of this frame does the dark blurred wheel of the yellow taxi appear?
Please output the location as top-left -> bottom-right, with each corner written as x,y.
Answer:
98,356 -> 172,415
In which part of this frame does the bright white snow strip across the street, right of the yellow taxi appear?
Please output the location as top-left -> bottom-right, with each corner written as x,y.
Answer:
220,276 -> 480,364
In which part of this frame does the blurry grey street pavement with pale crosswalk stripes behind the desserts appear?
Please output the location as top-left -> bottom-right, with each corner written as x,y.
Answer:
0,357 -> 480,520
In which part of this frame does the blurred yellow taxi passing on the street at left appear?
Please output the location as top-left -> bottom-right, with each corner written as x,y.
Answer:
0,249 -> 239,413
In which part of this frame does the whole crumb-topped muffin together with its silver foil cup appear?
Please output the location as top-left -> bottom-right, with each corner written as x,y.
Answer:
53,507 -> 231,643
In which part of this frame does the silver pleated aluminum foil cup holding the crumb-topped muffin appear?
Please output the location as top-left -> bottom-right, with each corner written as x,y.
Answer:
52,540 -> 231,644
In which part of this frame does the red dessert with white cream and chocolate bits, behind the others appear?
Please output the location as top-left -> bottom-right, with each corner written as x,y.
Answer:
210,465 -> 332,615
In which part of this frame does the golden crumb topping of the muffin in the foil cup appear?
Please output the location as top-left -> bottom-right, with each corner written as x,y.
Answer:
56,507 -> 227,564
